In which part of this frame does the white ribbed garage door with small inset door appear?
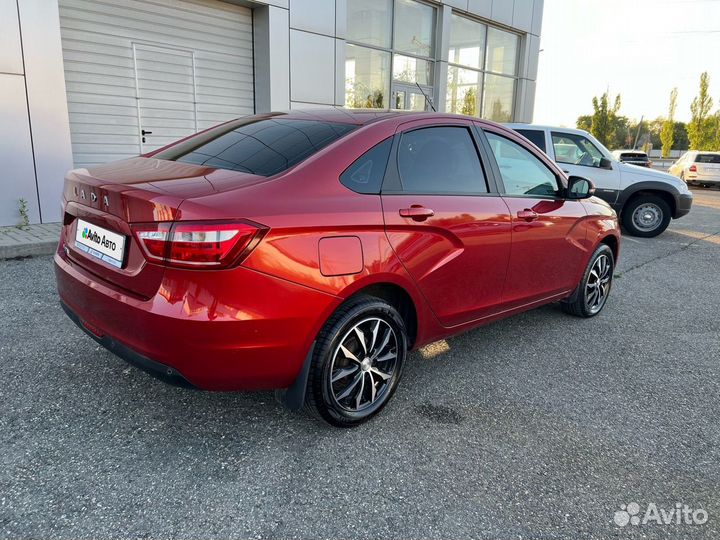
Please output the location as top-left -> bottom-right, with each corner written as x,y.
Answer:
59,0 -> 254,167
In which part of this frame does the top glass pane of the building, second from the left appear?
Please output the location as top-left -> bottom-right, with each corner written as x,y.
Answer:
390,0 -> 435,57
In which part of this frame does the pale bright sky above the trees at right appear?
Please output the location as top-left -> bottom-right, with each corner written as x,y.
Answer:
534,0 -> 720,127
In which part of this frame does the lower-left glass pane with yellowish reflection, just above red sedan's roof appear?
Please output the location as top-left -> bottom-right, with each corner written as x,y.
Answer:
345,44 -> 390,109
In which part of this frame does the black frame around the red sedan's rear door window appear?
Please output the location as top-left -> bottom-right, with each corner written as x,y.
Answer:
380,121 -> 501,197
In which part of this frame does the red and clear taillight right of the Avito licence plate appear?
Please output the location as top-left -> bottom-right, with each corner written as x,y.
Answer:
132,221 -> 266,268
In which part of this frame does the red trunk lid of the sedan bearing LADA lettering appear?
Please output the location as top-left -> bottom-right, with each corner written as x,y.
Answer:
63,157 -> 264,298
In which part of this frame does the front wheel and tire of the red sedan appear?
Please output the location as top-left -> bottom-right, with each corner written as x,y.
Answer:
560,244 -> 615,318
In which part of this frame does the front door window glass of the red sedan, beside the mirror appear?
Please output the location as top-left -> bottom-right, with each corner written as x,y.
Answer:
486,133 -> 558,197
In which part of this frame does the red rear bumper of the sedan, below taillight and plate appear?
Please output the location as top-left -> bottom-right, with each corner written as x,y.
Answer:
55,247 -> 341,391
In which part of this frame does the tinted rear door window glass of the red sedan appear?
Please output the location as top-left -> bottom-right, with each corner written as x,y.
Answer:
398,127 -> 487,193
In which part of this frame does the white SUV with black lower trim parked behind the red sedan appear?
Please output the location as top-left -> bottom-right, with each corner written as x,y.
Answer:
508,124 -> 692,238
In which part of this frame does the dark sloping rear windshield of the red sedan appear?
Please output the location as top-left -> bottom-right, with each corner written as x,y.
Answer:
154,118 -> 355,176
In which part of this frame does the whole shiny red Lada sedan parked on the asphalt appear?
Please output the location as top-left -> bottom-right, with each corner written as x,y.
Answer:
55,109 -> 620,426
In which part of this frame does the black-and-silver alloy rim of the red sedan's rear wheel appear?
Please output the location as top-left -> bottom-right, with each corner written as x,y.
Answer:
330,317 -> 398,412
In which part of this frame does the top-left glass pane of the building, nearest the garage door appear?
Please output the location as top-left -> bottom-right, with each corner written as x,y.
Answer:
347,0 -> 393,48
